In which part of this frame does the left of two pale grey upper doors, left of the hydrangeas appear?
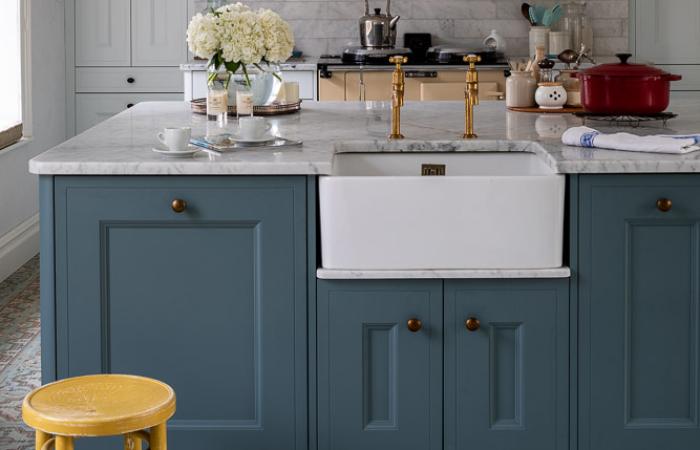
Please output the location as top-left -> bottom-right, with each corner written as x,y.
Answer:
75,0 -> 131,66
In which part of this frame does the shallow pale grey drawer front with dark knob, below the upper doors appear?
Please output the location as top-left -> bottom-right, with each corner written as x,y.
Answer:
75,67 -> 183,93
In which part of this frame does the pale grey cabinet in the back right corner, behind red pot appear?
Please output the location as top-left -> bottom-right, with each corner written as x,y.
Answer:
630,0 -> 700,91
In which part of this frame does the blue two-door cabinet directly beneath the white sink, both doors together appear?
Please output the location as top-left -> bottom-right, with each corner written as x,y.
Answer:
317,279 -> 569,450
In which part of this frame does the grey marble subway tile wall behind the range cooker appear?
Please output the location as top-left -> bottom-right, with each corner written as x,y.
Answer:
190,0 -> 629,56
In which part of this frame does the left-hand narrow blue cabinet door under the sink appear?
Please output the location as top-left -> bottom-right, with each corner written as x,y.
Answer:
318,280 -> 442,450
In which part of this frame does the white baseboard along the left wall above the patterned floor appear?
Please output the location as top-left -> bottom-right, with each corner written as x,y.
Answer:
0,214 -> 39,281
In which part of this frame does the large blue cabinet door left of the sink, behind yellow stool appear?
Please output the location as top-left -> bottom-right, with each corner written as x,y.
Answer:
55,177 -> 307,450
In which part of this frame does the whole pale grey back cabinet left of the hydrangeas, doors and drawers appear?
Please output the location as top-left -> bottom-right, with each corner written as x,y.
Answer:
66,0 -> 188,135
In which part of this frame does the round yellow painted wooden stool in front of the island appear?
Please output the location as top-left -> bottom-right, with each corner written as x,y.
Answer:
22,375 -> 175,450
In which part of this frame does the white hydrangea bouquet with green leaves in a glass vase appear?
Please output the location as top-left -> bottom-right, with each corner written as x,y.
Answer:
187,3 -> 294,86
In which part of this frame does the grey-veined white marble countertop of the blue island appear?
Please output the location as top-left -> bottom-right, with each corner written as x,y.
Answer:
29,93 -> 700,175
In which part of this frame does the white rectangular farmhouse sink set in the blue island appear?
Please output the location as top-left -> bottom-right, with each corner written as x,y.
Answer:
319,152 -> 565,270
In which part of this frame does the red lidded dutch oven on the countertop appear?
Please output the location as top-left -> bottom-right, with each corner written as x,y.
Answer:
577,53 -> 683,115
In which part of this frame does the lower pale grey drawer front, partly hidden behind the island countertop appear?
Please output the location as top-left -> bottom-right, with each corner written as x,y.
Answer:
75,94 -> 182,133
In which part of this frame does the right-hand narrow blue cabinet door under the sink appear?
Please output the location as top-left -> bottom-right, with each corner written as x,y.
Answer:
445,279 -> 569,450
